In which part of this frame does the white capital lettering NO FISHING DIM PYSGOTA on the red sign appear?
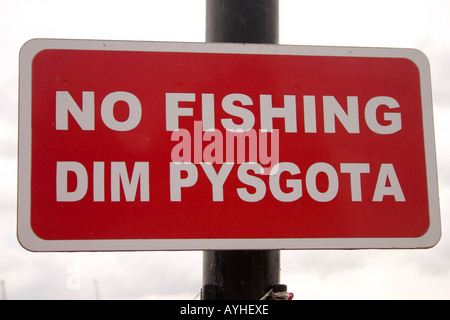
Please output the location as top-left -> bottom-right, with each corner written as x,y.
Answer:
55,91 -> 405,202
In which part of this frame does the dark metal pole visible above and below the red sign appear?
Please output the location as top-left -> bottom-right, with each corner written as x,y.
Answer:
202,0 -> 280,300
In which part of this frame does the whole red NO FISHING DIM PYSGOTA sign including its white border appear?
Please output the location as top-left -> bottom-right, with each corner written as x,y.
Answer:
18,40 -> 441,251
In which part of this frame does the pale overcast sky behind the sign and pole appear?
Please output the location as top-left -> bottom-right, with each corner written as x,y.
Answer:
0,0 -> 450,299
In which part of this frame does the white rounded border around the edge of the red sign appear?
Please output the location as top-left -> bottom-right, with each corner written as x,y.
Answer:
17,39 -> 441,252
